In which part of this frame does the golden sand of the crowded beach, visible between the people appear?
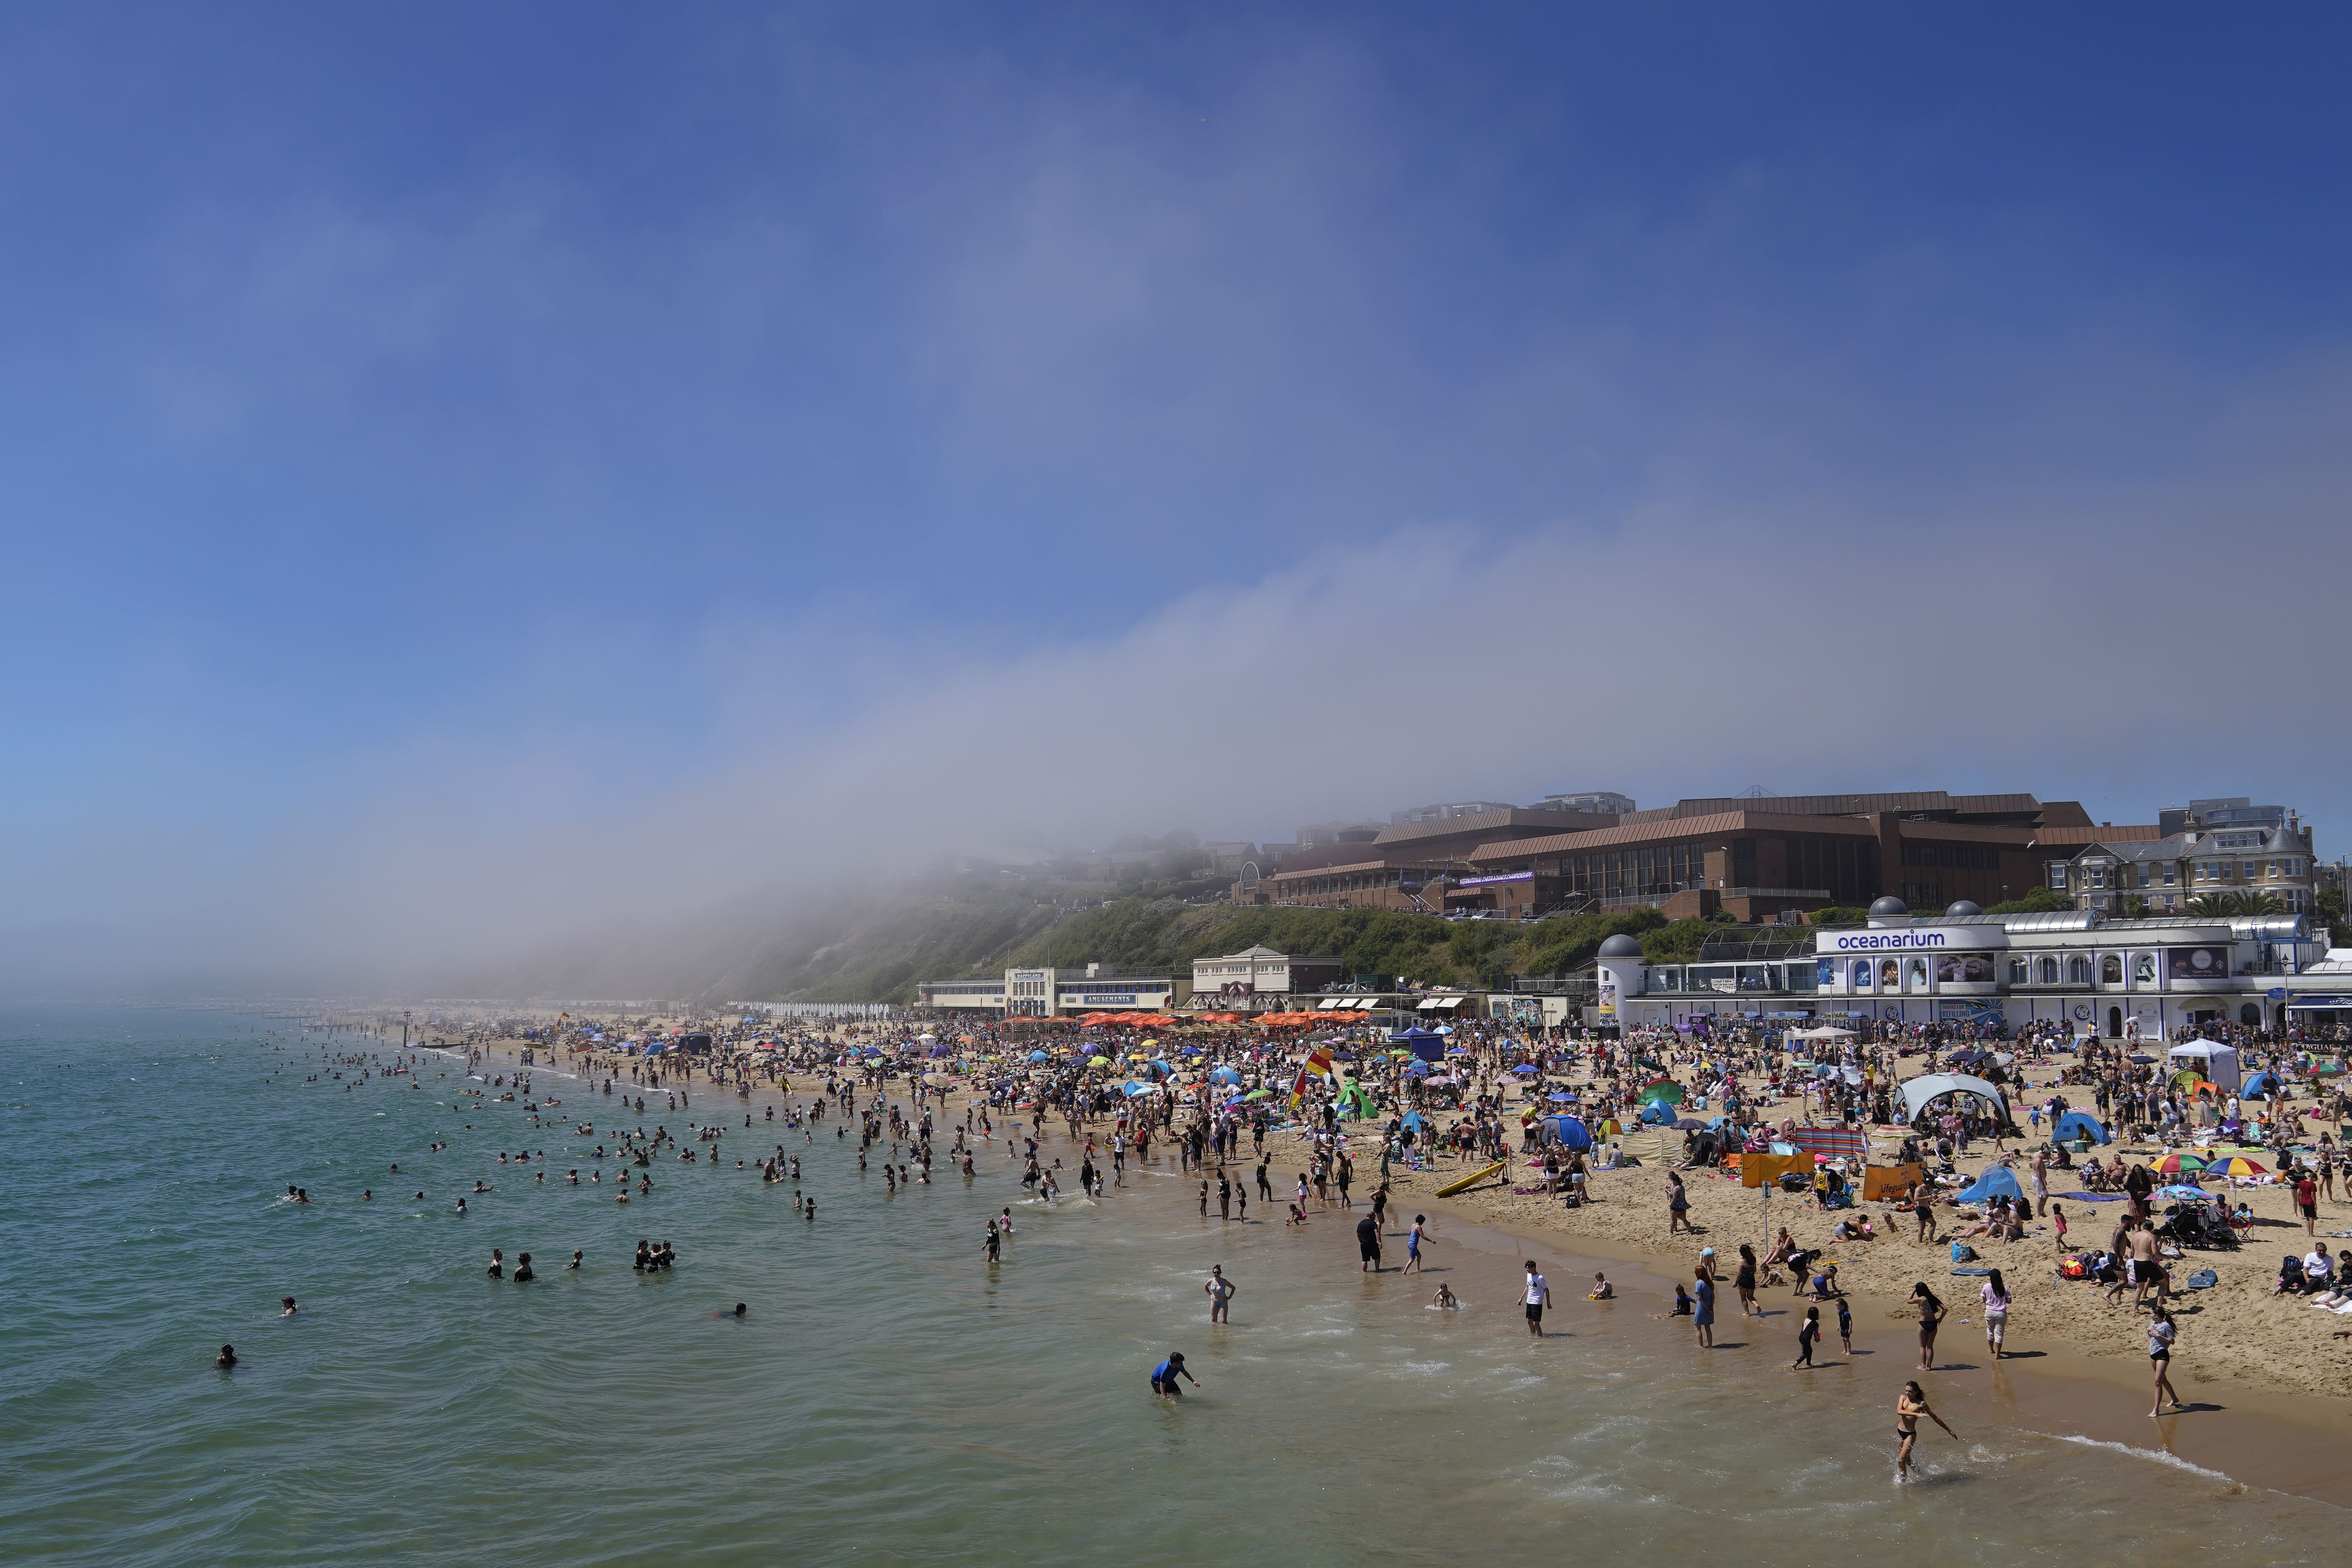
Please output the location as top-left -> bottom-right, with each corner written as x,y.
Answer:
423,1020 -> 2352,1507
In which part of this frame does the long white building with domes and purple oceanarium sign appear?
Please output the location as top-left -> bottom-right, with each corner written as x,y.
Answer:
1595,898 -> 2352,1039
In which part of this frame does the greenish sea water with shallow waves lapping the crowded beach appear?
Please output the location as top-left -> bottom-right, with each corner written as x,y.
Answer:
0,1009 -> 2343,1568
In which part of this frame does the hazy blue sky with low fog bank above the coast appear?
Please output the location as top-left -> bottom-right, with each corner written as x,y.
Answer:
0,5 -> 2352,992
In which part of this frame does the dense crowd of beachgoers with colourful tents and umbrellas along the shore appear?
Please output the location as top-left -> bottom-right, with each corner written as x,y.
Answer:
239,1016 -> 2352,1467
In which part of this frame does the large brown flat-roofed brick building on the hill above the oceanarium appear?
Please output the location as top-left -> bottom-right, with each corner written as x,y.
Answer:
1470,790 -> 2089,919
